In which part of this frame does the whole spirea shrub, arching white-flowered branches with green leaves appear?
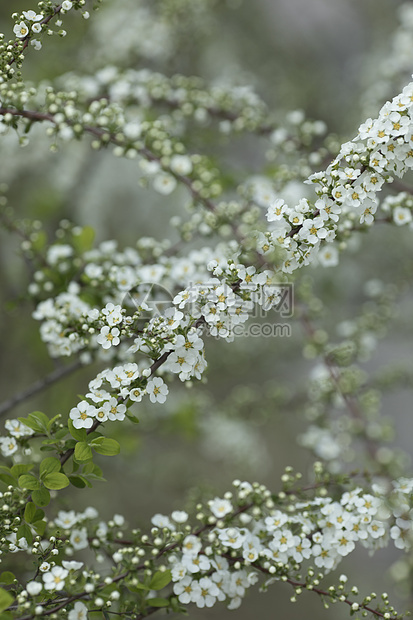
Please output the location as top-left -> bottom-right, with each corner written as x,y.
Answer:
0,0 -> 413,620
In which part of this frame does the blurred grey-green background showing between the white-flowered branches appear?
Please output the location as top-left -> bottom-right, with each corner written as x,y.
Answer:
0,0 -> 413,620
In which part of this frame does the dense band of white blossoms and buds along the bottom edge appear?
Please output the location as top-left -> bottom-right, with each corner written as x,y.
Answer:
2,468 -> 406,618
